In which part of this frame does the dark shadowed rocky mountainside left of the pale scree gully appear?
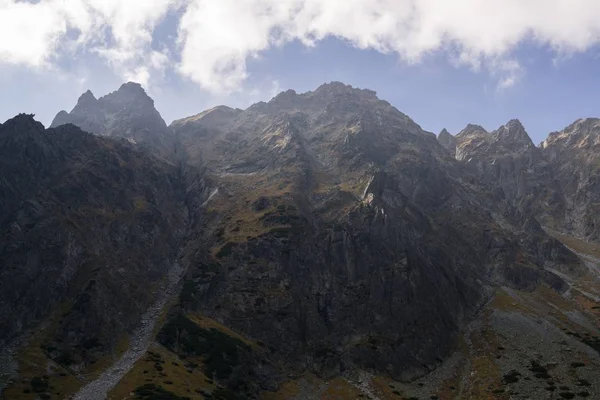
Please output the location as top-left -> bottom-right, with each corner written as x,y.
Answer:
0,115 -> 187,367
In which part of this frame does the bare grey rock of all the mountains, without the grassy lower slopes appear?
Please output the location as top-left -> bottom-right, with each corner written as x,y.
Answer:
0,82 -> 600,397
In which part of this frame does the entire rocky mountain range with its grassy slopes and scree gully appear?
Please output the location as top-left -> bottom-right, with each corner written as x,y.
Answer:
0,82 -> 600,399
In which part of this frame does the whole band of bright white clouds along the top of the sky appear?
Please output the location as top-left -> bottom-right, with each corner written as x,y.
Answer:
0,0 -> 600,93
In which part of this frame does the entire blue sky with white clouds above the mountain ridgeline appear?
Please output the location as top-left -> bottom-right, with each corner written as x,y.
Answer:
0,0 -> 600,142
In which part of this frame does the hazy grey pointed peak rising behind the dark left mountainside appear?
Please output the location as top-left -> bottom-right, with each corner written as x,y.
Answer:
50,82 -> 175,156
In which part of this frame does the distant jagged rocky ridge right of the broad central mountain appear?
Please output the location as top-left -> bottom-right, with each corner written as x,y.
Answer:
438,118 -> 600,241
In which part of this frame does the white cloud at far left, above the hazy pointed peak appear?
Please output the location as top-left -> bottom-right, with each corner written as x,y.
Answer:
0,0 -> 180,83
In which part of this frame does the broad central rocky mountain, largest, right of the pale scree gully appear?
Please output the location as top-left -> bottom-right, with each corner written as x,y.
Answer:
172,83 -> 581,379
